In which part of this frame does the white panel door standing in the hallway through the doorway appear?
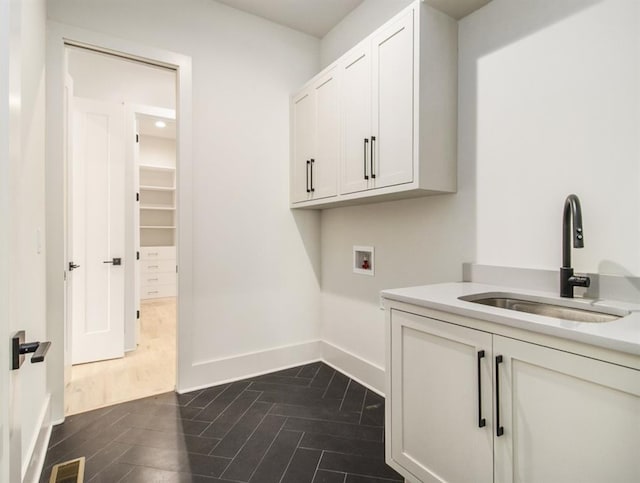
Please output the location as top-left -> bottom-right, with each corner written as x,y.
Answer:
70,98 -> 125,364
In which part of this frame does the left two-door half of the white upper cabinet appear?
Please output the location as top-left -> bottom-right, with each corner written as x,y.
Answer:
291,69 -> 340,203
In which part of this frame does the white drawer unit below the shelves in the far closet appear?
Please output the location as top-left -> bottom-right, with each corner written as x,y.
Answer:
140,246 -> 176,300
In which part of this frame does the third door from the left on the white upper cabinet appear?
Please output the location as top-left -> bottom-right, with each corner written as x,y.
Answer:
340,40 -> 371,194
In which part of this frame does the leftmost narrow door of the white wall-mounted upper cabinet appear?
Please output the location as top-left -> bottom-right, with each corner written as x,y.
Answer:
291,89 -> 315,203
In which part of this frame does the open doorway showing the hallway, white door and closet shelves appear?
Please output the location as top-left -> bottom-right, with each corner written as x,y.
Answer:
64,46 -> 178,415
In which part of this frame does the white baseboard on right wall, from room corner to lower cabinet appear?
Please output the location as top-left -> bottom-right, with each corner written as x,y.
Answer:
321,341 -> 385,397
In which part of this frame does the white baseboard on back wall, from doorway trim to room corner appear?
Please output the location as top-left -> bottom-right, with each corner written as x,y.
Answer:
176,340 -> 322,394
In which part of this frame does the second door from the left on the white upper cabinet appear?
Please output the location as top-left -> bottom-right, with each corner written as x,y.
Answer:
310,69 -> 340,199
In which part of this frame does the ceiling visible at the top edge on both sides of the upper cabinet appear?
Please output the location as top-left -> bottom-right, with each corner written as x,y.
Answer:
218,0 -> 491,38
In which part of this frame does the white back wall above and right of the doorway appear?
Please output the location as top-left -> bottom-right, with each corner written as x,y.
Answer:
48,0 -> 319,388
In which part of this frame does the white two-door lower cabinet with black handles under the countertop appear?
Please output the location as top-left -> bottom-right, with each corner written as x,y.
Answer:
386,309 -> 640,483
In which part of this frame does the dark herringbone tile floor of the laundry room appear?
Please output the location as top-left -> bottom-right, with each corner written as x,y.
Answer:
40,362 -> 403,483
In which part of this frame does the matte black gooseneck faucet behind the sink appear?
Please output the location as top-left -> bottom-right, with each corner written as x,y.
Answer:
560,195 -> 591,298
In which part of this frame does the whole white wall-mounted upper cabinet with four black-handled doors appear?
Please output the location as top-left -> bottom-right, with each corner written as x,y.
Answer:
291,1 -> 457,208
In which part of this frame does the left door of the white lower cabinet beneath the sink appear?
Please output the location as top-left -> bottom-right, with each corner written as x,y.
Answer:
387,310 -> 493,483
